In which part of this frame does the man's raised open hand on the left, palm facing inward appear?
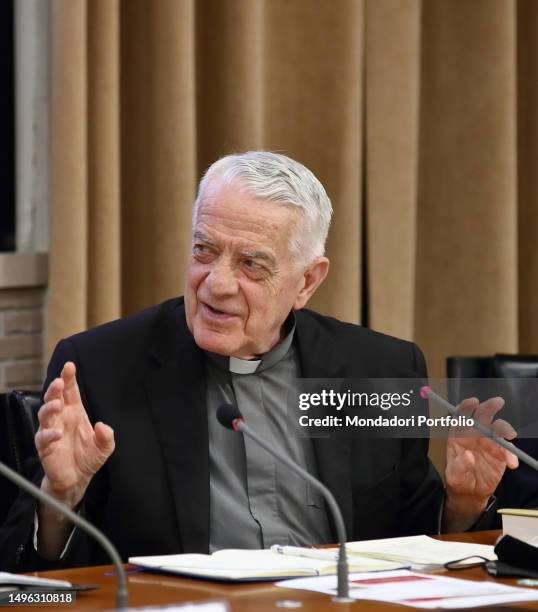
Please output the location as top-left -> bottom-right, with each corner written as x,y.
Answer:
35,362 -> 114,507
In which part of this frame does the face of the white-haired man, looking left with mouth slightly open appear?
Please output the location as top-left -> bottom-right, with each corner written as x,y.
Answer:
185,179 -> 306,359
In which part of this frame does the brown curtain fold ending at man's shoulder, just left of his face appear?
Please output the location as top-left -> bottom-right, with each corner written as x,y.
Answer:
121,0 -> 196,313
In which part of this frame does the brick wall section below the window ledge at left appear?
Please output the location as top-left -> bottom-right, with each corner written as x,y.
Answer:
0,287 -> 44,392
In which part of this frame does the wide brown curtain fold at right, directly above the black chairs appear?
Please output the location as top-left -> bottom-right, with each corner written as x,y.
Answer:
415,0 -> 517,376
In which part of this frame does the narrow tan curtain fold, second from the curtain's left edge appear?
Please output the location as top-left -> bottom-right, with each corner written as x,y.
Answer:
86,0 -> 121,326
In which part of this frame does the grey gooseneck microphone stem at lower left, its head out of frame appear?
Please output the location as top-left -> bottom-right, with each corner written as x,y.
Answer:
0,461 -> 128,609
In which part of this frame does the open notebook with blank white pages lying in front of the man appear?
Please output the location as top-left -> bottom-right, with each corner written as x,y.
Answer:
129,549 -> 400,582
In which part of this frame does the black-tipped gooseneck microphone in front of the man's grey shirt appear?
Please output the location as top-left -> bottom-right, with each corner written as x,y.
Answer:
217,404 -> 355,603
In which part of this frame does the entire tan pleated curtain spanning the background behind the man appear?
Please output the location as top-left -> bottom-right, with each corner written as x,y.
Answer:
48,0 -> 538,376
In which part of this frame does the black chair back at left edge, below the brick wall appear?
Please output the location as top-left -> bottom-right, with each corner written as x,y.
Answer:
0,390 -> 41,525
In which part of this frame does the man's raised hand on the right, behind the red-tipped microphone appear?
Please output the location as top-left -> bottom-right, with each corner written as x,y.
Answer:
445,397 -> 518,531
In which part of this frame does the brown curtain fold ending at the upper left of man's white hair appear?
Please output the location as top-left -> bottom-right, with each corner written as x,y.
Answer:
196,0 -> 265,167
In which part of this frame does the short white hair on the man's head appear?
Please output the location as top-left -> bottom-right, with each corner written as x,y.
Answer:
192,151 -> 333,264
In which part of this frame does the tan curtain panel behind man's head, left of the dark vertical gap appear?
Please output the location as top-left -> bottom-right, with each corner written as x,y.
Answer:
48,0 -> 364,351
